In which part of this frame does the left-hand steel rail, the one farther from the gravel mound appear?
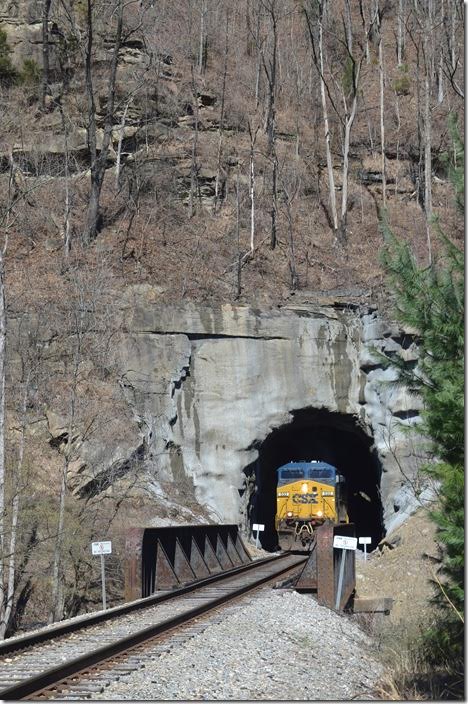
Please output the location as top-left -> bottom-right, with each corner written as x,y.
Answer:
0,553 -> 286,656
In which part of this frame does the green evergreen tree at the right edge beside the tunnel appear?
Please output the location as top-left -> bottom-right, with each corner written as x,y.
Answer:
381,122 -> 465,670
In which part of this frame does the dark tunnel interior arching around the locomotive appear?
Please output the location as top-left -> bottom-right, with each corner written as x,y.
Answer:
244,409 -> 385,551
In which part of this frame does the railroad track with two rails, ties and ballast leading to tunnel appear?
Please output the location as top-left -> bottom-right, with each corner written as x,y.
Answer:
0,553 -> 307,701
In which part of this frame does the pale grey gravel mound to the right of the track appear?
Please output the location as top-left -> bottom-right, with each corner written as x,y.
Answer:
93,589 -> 383,701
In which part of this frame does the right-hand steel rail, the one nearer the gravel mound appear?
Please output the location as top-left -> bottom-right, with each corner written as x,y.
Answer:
0,555 -> 307,701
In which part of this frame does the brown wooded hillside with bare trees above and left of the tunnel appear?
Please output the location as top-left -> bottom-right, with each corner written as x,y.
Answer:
0,0 -> 464,648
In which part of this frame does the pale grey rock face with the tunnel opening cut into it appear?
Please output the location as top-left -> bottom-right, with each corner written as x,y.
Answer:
93,286 -> 426,534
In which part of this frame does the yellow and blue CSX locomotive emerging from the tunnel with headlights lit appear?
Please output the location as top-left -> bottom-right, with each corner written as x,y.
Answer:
275,460 -> 349,549
